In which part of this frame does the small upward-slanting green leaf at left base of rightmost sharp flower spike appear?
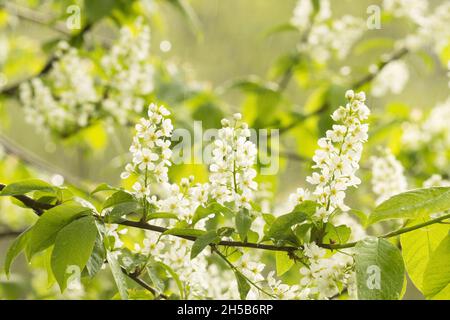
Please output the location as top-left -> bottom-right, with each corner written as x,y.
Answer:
266,201 -> 316,245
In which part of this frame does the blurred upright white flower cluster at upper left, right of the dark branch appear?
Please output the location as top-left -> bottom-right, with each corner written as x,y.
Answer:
101,18 -> 154,124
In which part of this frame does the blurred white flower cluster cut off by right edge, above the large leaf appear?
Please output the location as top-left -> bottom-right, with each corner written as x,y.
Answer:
402,98 -> 450,171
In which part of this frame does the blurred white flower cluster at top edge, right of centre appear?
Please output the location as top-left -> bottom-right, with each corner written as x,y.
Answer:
291,0 -> 366,63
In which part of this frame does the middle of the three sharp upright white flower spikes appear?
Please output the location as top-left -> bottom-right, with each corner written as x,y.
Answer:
209,113 -> 258,209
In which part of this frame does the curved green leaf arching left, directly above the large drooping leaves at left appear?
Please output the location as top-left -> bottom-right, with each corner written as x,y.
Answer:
26,203 -> 91,259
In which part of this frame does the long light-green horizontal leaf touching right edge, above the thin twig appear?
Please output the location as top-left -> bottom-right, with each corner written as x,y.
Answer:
368,187 -> 450,224
